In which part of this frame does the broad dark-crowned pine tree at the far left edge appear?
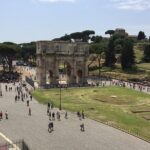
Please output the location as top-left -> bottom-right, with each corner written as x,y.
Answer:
0,42 -> 20,72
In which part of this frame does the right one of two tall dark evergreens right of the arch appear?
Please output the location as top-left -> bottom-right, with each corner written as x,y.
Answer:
121,38 -> 135,70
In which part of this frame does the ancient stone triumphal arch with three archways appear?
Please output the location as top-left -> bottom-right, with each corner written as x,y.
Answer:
36,41 -> 89,87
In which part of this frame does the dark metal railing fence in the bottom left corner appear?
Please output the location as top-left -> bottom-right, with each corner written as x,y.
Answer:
0,140 -> 30,150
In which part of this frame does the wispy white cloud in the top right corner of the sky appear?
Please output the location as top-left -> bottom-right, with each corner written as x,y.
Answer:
110,0 -> 150,10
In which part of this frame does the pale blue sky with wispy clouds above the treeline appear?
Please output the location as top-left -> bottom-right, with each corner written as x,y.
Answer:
0,0 -> 150,43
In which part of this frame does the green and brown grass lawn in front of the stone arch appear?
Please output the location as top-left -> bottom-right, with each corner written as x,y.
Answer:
33,87 -> 150,141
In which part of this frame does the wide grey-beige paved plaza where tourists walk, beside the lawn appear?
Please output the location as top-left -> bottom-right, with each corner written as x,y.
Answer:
0,84 -> 150,150
